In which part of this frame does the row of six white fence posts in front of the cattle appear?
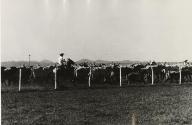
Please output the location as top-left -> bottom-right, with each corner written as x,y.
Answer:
19,66 -> 182,92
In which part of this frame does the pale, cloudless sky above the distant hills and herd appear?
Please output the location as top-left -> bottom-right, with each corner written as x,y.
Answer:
1,0 -> 192,61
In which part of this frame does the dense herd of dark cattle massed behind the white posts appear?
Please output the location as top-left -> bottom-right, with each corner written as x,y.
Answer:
1,60 -> 192,89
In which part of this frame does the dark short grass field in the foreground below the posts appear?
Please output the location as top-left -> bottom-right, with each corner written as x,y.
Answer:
1,85 -> 192,125
